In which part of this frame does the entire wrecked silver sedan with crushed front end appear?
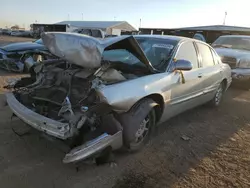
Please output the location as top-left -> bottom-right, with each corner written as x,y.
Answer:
6,33 -> 231,163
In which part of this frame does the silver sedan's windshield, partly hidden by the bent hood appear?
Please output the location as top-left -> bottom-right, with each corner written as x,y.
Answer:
103,37 -> 178,69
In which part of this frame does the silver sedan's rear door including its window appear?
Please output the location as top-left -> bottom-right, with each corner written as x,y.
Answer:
196,42 -> 222,100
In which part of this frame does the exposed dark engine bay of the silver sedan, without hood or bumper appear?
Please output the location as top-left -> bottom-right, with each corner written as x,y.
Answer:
13,60 -> 147,150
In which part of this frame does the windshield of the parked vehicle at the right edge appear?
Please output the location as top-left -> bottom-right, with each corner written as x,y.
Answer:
212,37 -> 250,50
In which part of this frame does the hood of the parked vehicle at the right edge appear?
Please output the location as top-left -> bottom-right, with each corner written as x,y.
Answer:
214,48 -> 250,59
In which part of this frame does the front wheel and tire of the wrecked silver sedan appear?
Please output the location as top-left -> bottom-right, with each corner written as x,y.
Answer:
119,99 -> 158,152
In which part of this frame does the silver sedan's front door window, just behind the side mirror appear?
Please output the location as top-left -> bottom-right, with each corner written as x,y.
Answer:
175,42 -> 198,69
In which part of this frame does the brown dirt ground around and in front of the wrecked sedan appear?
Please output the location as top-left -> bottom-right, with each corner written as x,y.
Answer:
0,36 -> 250,188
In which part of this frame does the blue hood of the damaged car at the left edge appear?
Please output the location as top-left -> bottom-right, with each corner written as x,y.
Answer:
1,42 -> 46,52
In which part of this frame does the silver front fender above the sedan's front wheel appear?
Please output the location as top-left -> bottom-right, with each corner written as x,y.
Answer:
96,73 -> 171,113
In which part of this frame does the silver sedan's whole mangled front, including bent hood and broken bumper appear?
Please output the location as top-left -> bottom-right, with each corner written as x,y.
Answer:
6,33 -> 153,163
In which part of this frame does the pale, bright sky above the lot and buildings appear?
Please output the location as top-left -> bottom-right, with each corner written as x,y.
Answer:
0,0 -> 250,28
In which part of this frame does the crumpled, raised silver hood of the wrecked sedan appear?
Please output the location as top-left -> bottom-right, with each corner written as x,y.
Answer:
42,32 -> 156,72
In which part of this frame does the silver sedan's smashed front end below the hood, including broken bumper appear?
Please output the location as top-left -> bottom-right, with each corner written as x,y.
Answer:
6,60 -> 125,163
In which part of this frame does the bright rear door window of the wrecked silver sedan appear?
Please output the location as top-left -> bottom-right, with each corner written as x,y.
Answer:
197,42 -> 214,67
